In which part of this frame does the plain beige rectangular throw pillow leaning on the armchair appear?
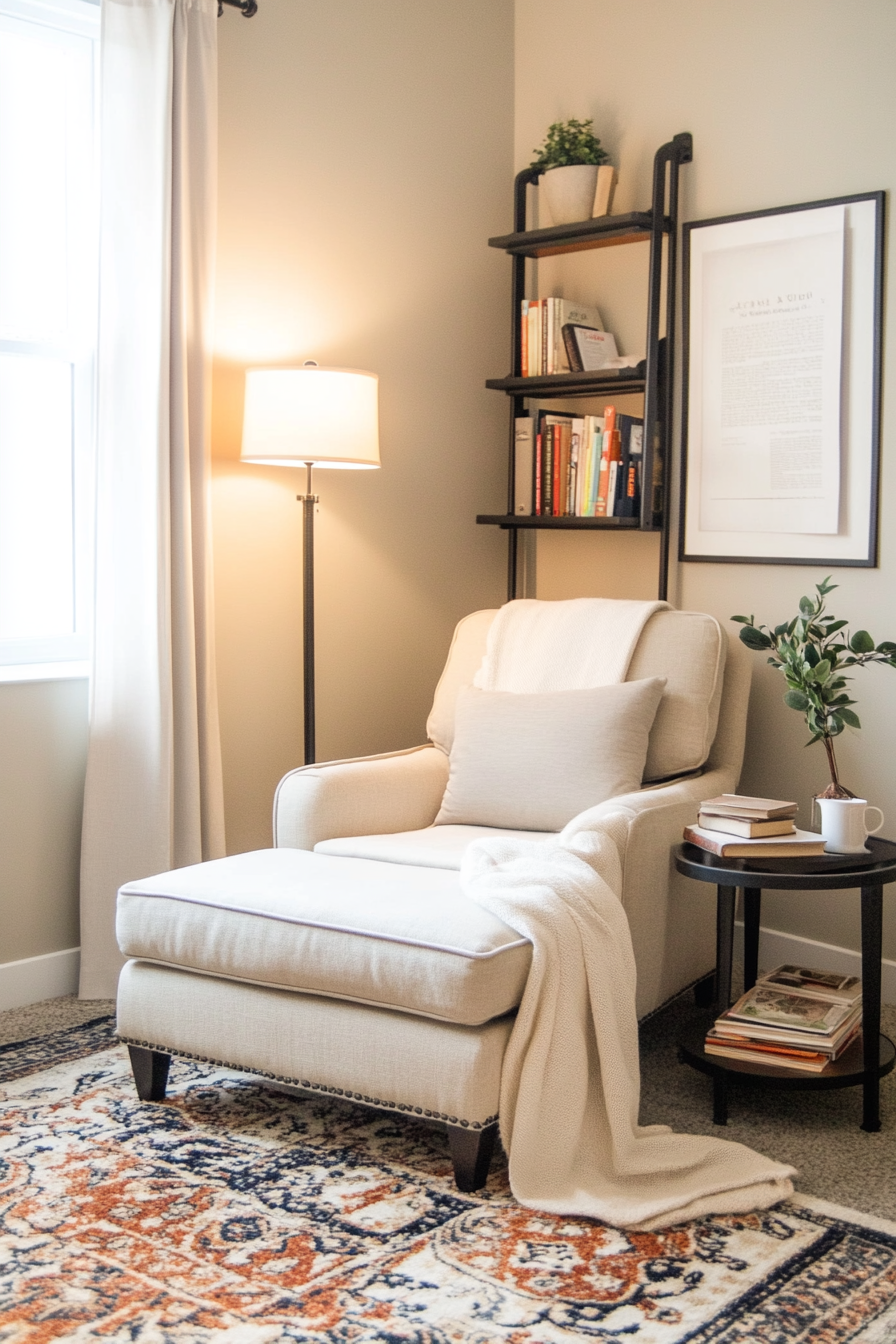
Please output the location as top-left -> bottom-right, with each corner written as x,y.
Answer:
435,677 -> 666,831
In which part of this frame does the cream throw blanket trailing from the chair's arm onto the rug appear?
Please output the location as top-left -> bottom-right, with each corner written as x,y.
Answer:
462,810 -> 795,1231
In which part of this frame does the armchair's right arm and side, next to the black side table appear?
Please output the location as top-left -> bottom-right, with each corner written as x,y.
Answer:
560,769 -> 737,1016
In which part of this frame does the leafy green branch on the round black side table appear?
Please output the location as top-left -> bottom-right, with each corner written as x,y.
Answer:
731,577 -> 896,798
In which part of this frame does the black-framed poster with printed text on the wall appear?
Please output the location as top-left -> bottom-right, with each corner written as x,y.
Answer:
678,191 -> 884,567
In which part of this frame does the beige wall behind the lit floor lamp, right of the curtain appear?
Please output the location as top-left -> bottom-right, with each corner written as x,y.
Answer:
214,0 -> 513,852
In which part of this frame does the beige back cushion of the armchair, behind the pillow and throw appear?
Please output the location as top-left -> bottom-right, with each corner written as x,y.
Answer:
426,610 -> 728,784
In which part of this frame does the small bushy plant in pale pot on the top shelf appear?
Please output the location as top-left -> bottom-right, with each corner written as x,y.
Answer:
531,117 -> 614,224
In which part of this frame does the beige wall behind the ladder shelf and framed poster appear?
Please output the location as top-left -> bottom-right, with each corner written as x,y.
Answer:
516,0 -> 896,957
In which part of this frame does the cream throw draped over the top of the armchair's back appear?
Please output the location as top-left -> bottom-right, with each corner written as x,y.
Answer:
473,597 -> 669,695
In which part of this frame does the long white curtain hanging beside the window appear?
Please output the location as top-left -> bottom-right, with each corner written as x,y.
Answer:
81,0 -> 224,999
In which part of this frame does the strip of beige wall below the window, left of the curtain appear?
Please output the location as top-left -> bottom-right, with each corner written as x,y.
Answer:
0,680 -> 87,965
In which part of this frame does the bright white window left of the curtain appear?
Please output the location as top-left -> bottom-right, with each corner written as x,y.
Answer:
0,0 -> 99,680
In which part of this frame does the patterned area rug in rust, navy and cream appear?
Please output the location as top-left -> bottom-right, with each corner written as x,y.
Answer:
0,1020 -> 896,1344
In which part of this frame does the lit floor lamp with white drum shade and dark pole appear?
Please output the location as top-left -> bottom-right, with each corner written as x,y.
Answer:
240,360 -> 380,765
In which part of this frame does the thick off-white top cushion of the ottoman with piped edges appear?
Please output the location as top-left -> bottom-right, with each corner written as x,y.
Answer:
117,849 -> 532,1025
